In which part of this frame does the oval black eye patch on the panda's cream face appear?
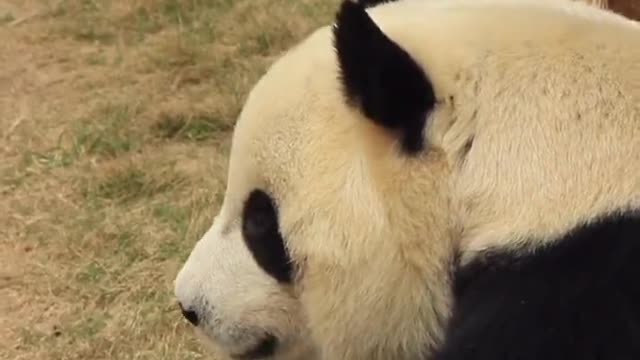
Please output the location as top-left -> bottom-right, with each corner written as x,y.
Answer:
242,190 -> 292,283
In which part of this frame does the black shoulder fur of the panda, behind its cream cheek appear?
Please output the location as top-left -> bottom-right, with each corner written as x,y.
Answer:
432,212 -> 640,360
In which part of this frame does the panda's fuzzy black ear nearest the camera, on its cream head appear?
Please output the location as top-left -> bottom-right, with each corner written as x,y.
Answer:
333,0 -> 436,153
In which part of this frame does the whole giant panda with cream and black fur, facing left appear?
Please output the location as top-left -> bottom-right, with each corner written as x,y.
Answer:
175,0 -> 640,360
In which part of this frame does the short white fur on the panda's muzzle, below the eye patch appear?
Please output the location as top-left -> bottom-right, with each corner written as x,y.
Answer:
175,215 -> 316,354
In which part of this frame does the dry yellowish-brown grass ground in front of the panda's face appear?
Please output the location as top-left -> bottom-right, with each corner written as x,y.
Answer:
0,0 -> 337,360
